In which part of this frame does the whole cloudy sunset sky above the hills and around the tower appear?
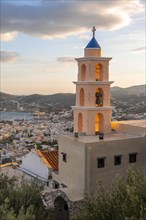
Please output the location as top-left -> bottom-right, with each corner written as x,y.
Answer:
0,0 -> 146,95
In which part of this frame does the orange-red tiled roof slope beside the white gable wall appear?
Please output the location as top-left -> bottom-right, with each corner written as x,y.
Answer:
35,150 -> 58,170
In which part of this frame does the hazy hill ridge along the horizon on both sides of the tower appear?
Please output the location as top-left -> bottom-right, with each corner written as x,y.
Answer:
0,85 -> 146,107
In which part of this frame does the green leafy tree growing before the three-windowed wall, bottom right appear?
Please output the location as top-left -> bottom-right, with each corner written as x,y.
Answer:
75,168 -> 146,220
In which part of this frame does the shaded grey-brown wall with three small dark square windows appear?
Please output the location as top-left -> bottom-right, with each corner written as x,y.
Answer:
86,137 -> 145,192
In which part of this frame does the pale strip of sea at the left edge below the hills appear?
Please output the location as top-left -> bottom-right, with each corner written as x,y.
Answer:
0,111 -> 33,121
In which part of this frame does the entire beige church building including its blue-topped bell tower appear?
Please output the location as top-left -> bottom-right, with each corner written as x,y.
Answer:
45,27 -> 146,220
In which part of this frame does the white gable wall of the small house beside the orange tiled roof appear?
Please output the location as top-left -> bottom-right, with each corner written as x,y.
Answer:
21,151 -> 50,180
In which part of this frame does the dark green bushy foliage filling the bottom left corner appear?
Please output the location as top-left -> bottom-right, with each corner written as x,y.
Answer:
0,175 -> 52,220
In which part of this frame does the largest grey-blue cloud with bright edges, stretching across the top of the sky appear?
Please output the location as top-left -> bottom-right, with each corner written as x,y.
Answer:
1,0 -> 144,39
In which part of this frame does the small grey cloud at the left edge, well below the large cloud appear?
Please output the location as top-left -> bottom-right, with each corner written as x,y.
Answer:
0,51 -> 19,63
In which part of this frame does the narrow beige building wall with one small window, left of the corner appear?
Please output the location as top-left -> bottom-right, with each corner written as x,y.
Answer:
59,136 -> 85,198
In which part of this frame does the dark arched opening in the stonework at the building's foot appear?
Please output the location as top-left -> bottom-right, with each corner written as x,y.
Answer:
54,196 -> 69,220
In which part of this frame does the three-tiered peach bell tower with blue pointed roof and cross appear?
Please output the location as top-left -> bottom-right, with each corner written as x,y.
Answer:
72,27 -> 113,135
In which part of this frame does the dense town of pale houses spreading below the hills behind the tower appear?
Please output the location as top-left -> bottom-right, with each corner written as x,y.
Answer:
0,101 -> 146,168
